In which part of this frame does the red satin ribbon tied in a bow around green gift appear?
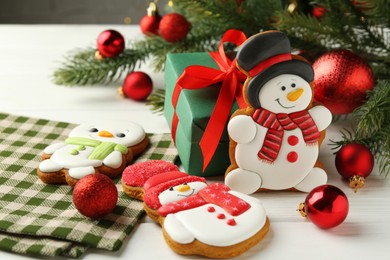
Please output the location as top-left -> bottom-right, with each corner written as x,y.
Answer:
172,29 -> 247,171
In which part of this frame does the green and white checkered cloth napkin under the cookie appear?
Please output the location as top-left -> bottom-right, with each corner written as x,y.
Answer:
0,113 -> 177,257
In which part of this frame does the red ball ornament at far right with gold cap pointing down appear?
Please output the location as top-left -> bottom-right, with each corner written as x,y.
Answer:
335,143 -> 374,192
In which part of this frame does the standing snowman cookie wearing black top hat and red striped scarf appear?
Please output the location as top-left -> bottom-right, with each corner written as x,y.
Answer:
225,31 -> 332,194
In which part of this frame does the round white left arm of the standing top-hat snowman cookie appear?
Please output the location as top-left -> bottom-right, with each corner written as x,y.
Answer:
227,115 -> 257,143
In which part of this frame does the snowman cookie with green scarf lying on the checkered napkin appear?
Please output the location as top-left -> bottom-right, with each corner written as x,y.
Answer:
38,122 -> 149,186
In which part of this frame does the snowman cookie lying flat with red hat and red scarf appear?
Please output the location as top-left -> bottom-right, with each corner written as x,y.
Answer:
124,171 -> 269,258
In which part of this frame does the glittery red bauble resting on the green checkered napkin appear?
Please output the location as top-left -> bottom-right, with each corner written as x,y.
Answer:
73,173 -> 118,219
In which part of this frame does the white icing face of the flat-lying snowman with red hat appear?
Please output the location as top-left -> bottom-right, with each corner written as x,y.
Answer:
158,181 -> 207,205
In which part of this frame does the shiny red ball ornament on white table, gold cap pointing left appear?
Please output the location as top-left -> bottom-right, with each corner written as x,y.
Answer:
299,184 -> 349,229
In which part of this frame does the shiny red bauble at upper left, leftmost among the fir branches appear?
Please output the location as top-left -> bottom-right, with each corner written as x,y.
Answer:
97,30 -> 125,58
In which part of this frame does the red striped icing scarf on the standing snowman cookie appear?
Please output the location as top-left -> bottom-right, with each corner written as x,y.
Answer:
252,108 -> 321,163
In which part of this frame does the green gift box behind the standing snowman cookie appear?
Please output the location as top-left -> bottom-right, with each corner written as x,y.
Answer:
164,53 -> 238,177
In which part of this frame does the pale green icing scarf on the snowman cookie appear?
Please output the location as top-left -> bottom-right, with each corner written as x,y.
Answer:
65,137 -> 127,161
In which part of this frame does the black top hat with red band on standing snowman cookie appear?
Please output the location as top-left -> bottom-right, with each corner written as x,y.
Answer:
236,31 -> 314,108
